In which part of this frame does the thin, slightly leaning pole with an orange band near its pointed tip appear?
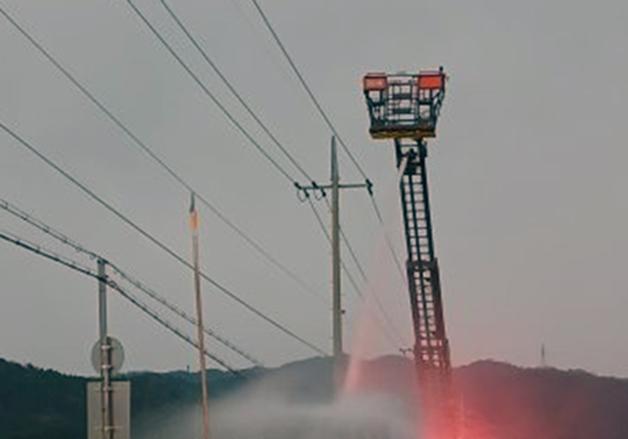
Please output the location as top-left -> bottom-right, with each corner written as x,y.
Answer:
190,193 -> 209,439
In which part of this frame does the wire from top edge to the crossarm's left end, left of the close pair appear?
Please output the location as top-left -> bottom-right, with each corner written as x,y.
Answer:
127,0 -> 299,188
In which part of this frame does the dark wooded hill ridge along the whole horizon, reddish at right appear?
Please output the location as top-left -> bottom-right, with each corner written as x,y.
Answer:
0,357 -> 628,439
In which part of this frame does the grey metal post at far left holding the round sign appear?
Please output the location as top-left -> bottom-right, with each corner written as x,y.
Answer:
97,259 -> 114,439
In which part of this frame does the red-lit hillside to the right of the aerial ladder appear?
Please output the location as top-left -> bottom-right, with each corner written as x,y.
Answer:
455,361 -> 628,439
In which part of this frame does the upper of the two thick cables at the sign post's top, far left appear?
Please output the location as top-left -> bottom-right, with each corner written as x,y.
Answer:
0,199 -> 262,366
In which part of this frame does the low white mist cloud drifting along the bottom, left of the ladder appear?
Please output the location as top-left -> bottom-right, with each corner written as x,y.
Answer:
134,362 -> 416,439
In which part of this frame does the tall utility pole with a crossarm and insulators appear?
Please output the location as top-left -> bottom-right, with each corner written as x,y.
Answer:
299,136 -> 371,360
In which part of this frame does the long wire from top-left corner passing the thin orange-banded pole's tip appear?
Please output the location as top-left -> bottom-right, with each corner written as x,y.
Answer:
0,2 -> 320,306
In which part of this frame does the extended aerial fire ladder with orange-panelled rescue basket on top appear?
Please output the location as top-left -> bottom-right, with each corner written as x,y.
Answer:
363,67 -> 457,439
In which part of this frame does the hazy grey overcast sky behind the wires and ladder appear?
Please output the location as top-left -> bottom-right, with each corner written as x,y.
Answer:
0,0 -> 628,377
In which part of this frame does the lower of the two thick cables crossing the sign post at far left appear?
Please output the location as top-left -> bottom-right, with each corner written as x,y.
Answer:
0,231 -> 240,375
